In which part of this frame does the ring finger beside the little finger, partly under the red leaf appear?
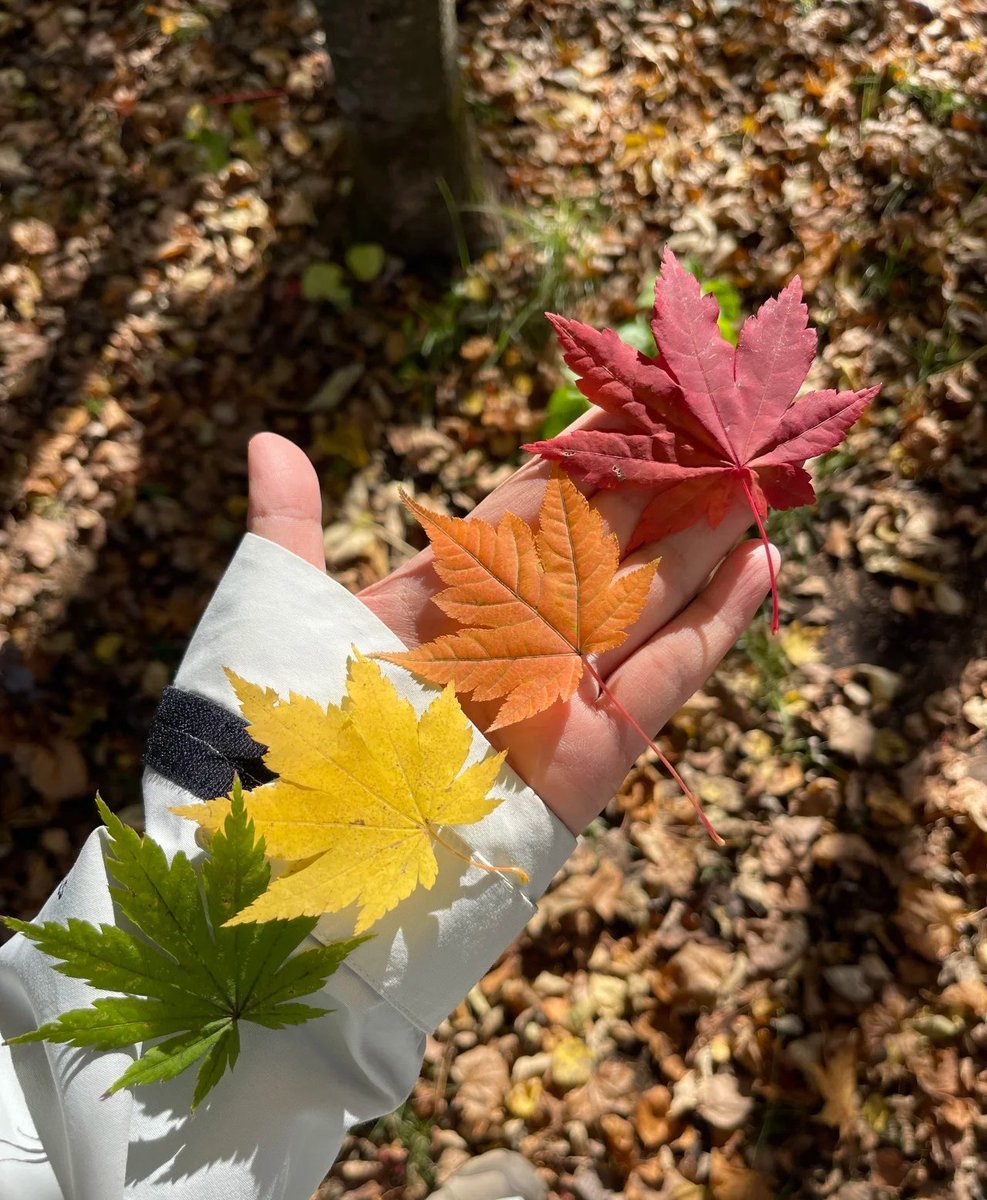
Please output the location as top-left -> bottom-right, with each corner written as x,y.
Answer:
598,504 -> 767,678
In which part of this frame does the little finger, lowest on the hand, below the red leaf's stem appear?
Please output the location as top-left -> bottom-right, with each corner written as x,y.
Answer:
599,541 -> 780,761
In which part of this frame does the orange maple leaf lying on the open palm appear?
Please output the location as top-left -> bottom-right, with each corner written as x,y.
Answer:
375,475 -> 658,730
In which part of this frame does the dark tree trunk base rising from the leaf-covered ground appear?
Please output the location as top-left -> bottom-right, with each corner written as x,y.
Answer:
316,0 -> 484,259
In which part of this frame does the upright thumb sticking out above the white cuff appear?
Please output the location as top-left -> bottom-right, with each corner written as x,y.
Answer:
247,433 -> 325,571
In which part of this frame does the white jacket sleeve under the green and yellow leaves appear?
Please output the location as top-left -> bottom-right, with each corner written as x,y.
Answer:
0,534 -> 575,1200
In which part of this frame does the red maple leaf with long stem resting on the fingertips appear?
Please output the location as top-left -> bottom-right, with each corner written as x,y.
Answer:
525,251 -> 880,632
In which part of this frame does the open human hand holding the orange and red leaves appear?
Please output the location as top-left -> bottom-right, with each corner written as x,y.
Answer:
247,429 -> 777,834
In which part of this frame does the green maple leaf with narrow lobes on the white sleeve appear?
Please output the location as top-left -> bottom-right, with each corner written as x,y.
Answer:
4,780 -> 366,1111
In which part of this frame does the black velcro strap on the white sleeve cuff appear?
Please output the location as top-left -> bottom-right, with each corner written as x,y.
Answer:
144,688 -> 277,800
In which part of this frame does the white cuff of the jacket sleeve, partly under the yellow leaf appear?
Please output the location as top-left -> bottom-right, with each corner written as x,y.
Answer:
144,534 -> 575,1032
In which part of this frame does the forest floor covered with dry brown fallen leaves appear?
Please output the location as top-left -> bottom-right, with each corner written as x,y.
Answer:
0,0 -> 987,1200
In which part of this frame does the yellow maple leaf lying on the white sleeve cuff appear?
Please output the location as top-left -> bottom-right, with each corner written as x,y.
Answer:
172,654 -> 526,934
